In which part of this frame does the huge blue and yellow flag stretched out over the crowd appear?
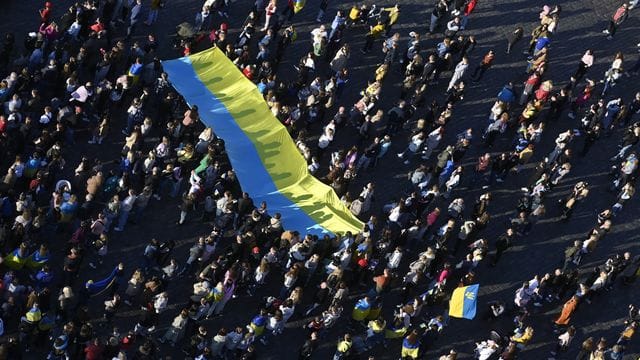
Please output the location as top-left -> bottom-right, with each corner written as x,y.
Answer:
162,48 -> 363,234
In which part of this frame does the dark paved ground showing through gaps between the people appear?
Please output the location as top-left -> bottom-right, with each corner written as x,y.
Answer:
0,0 -> 640,360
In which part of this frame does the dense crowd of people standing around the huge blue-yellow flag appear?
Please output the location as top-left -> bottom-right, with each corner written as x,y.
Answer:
0,0 -> 640,360
